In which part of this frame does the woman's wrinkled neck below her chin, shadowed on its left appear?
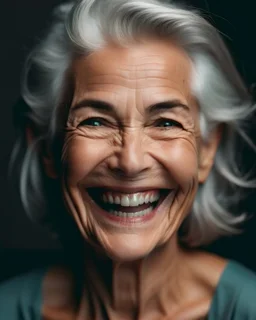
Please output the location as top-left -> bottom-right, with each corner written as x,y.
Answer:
80,238 -> 190,320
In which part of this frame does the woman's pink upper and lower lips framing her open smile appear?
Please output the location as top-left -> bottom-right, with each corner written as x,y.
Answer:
86,187 -> 174,227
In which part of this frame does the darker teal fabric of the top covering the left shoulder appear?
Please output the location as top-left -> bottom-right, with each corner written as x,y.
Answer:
0,268 -> 47,320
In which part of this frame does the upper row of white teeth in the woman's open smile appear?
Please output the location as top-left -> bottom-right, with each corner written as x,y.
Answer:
103,191 -> 160,207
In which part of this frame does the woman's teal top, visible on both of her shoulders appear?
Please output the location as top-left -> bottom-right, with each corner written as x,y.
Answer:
0,261 -> 256,320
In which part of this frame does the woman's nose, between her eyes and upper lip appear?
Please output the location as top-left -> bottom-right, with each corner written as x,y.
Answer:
106,129 -> 152,178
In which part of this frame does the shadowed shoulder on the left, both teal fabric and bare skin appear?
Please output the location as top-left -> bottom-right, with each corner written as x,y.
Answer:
0,266 -> 76,320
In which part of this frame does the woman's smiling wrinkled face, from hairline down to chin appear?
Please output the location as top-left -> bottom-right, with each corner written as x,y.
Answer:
49,41 -> 218,260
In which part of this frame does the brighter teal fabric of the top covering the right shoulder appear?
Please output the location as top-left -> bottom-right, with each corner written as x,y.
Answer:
210,261 -> 256,320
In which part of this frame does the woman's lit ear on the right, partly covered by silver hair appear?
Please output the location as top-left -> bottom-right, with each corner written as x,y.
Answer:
198,126 -> 222,183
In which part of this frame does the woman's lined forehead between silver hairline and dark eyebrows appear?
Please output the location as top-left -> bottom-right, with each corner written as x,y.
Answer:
73,40 -> 191,100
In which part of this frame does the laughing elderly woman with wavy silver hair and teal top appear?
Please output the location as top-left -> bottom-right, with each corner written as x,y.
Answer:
0,0 -> 256,320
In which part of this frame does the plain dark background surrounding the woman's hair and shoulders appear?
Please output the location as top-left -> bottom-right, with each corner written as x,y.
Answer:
0,0 -> 256,280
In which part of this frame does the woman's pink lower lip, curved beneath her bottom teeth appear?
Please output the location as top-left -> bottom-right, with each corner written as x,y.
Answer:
87,193 -> 170,226
